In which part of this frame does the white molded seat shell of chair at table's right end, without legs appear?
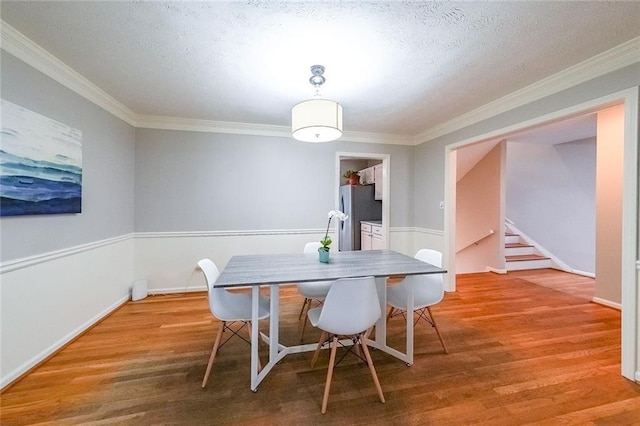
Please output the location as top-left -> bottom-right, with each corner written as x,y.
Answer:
400,249 -> 444,309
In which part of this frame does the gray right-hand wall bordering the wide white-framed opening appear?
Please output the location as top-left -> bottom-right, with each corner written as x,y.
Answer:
414,63 -> 640,230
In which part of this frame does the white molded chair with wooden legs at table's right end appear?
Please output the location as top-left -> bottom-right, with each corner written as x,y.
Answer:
387,249 -> 449,353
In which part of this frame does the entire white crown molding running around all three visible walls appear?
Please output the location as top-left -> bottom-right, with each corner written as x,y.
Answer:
0,21 -> 640,145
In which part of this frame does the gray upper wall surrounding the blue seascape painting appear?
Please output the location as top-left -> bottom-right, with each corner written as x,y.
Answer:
0,51 -> 135,261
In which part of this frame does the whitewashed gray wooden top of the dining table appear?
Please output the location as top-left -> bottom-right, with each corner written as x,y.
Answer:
216,250 -> 446,287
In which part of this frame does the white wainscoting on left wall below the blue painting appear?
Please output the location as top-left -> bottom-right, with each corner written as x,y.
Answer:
0,234 -> 133,388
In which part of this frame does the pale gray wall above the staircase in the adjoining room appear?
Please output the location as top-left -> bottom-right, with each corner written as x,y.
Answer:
506,138 -> 596,274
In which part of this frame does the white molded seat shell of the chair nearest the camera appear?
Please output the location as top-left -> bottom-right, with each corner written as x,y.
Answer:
317,277 -> 382,335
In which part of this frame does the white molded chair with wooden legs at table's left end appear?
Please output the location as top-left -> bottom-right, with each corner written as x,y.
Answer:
198,259 -> 269,388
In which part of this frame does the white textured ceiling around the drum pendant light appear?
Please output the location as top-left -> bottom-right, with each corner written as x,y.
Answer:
1,0 -> 640,135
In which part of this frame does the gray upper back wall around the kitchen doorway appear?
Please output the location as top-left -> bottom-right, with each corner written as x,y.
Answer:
135,129 -> 414,232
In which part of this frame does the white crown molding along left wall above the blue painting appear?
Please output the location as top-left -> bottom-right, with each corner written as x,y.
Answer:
0,21 -> 137,125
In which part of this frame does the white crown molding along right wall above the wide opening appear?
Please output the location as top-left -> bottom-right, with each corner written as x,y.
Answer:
414,37 -> 640,145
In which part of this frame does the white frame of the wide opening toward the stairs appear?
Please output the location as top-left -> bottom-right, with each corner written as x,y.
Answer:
444,87 -> 640,382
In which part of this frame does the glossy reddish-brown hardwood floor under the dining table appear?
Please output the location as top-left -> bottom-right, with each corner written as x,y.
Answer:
0,270 -> 640,425
